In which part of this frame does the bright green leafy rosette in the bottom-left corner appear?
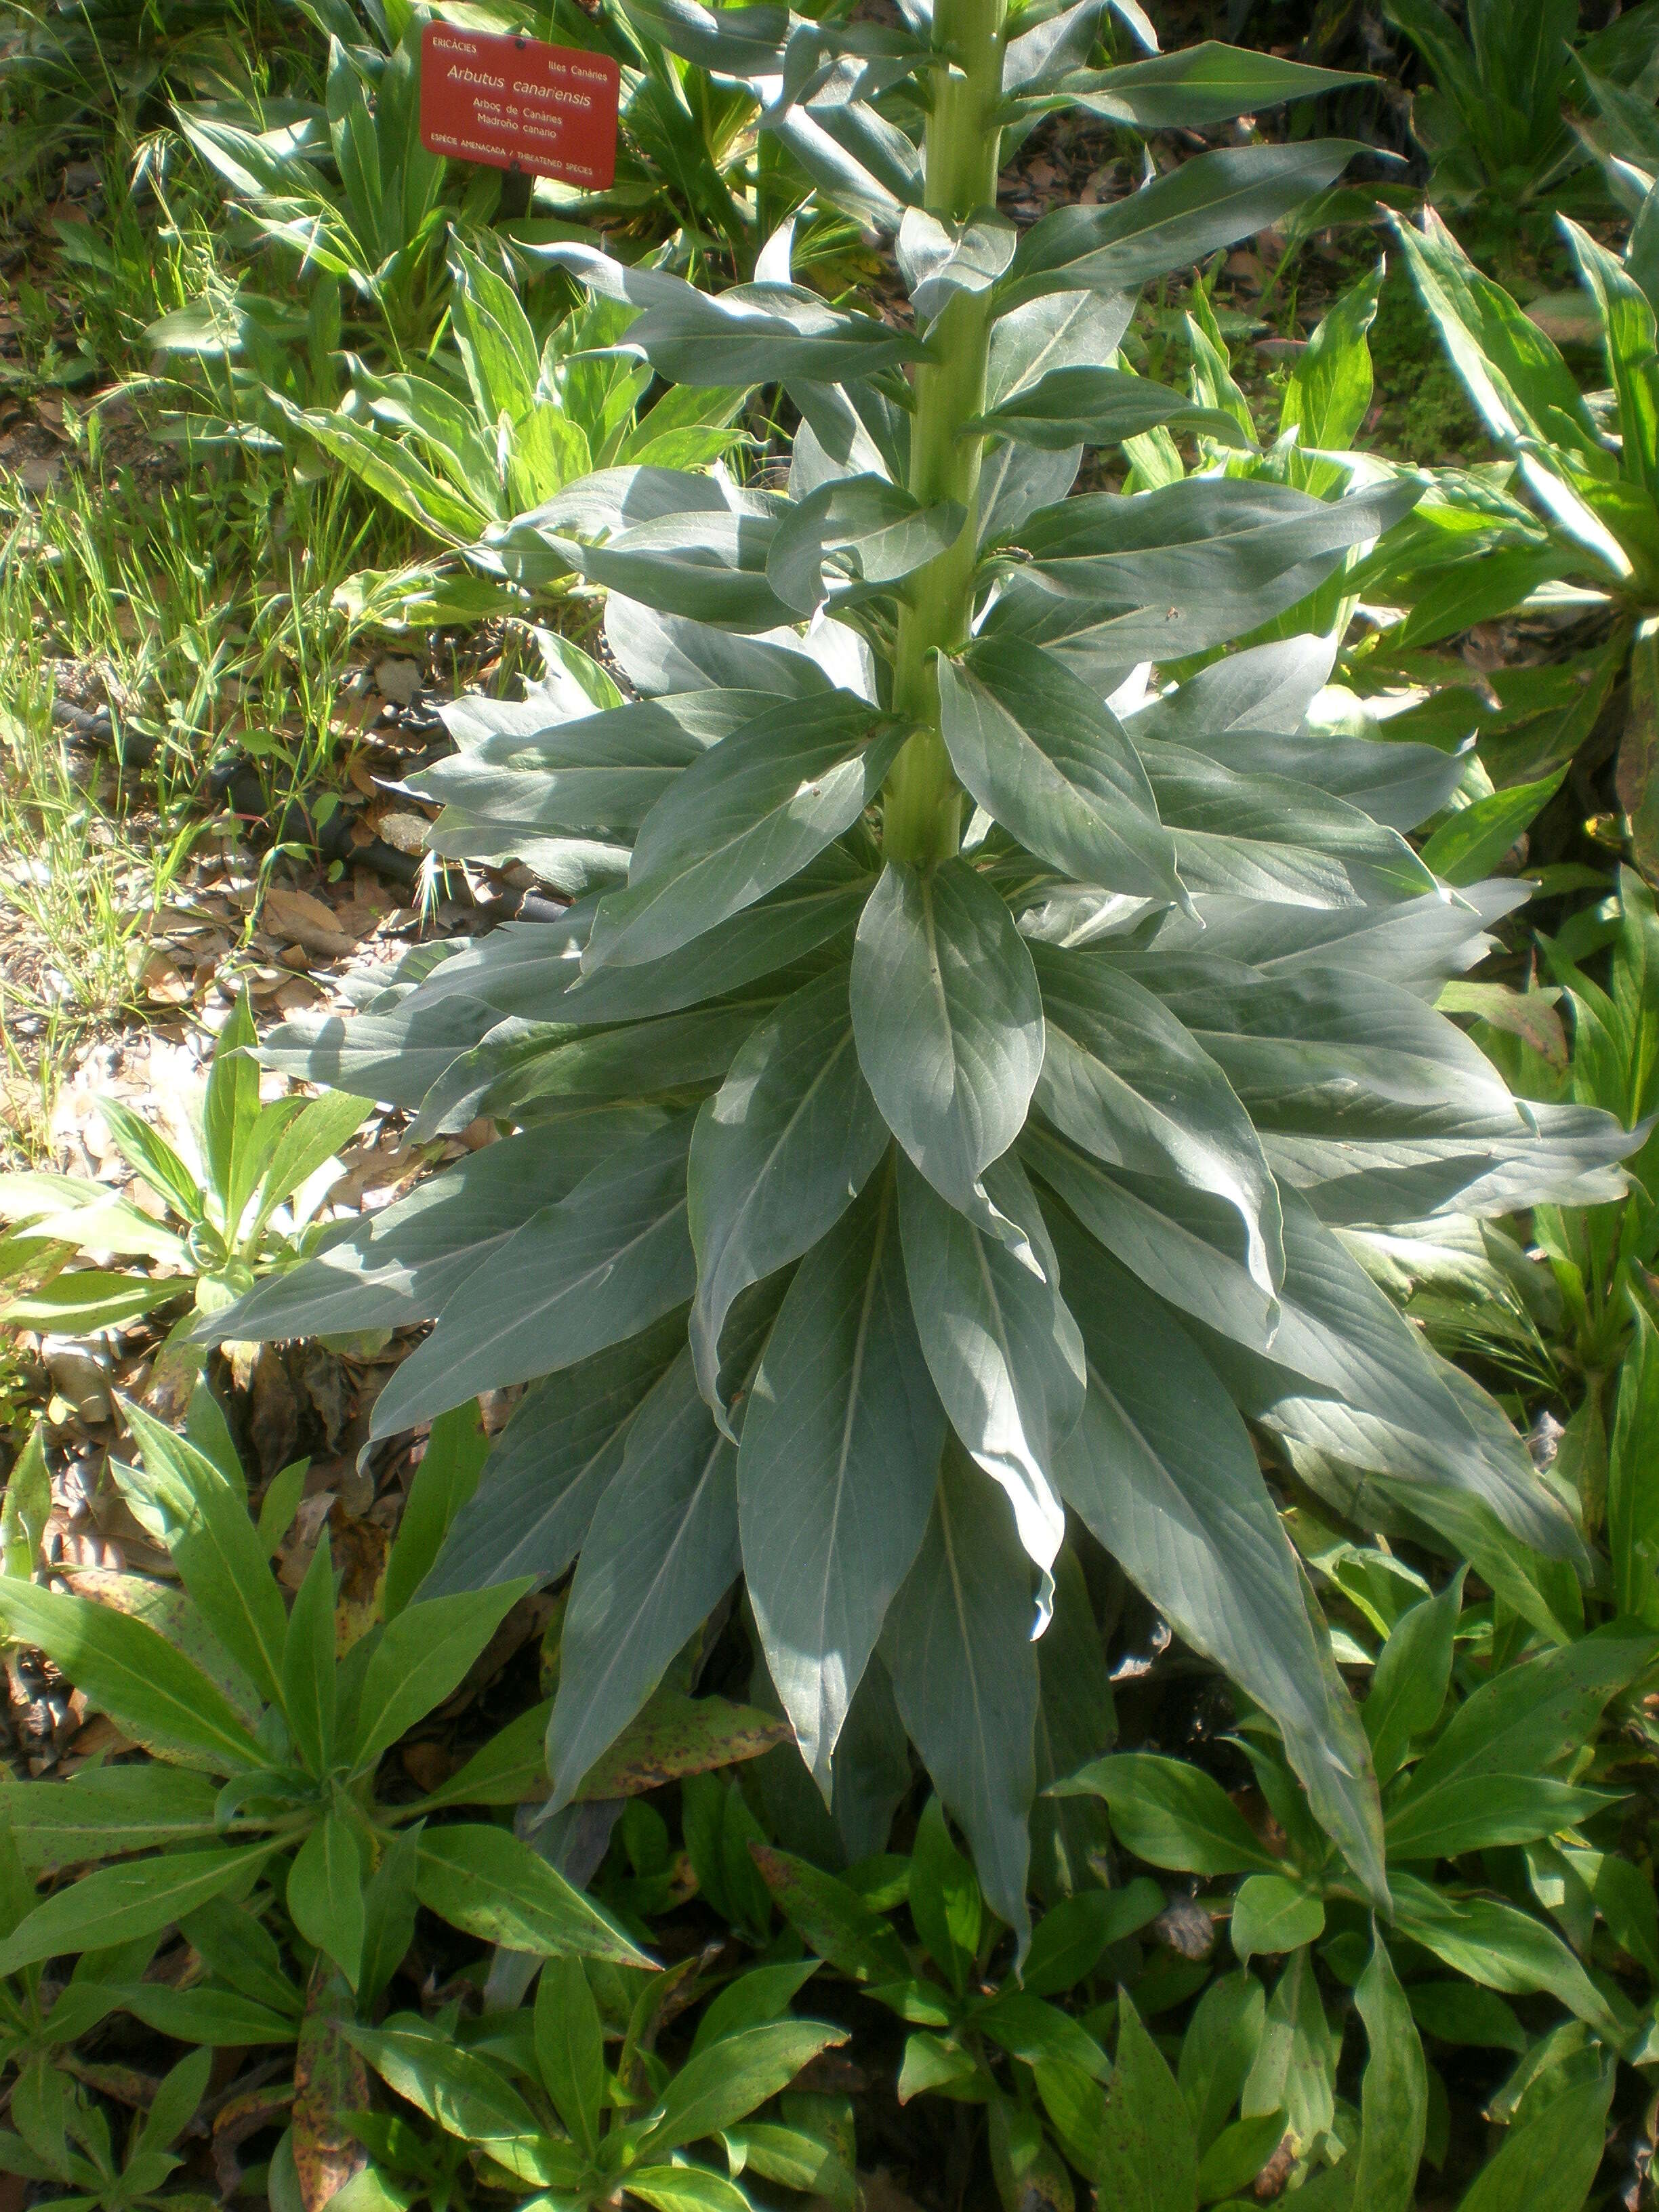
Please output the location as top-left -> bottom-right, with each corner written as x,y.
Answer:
0,1387 -> 648,2046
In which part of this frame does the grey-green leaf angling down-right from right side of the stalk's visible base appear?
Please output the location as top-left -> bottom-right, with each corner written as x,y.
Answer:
938,639 -> 1186,900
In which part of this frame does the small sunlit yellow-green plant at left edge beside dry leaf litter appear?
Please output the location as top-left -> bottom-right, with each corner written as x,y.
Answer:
0,991 -> 369,1336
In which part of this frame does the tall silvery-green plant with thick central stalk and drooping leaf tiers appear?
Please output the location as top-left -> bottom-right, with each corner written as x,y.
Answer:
208,26 -> 1631,1938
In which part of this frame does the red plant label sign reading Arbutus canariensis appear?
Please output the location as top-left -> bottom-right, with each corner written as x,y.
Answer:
420,22 -> 621,192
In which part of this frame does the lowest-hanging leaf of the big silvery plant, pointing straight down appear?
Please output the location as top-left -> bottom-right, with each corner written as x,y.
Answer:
880,1451 -> 1038,1944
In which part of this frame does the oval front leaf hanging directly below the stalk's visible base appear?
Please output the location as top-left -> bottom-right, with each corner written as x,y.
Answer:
852,861 -> 1042,1214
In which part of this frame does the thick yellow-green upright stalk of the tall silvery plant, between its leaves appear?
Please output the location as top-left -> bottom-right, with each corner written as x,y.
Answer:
882,0 -> 1004,867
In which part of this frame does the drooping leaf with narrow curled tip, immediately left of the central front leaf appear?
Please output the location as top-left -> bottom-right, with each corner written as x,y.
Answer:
690,966 -> 887,1418
